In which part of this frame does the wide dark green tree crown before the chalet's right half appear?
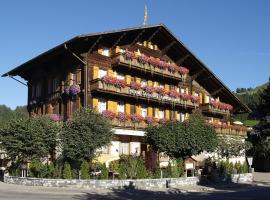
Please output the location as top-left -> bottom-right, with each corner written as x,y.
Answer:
146,113 -> 217,158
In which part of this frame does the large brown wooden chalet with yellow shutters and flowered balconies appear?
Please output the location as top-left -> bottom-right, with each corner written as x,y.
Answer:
3,25 -> 249,166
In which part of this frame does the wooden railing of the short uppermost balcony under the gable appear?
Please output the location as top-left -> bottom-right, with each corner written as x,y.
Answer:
112,53 -> 187,81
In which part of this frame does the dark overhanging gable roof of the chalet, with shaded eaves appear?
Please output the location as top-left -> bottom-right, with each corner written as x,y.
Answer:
2,24 -> 250,112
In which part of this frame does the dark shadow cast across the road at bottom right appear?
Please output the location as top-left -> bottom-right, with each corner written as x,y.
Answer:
73,185 -> 270,200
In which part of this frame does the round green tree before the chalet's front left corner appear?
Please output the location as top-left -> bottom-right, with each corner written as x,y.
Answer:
61,108 -> 113,166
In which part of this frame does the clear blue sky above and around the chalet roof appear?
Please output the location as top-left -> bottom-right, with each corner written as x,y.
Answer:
0,0 -> 270,108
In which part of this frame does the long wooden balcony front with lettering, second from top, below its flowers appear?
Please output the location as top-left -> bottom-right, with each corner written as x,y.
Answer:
91,79 -> 199,108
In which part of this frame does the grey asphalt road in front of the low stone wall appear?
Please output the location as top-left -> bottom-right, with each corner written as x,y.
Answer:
0,183 -> 270,200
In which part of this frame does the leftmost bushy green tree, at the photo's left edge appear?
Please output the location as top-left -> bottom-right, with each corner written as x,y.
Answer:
0,116 -> 60,162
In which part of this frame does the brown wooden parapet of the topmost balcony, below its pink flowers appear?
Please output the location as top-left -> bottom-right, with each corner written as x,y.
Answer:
112,54 -> 187,81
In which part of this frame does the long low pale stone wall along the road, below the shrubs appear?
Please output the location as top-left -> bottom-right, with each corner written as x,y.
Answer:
4,176 -> 199,189
